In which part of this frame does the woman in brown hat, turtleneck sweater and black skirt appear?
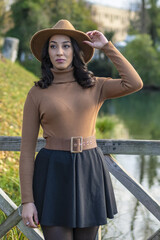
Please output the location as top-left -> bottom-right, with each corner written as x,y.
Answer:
20,20 -> 143,240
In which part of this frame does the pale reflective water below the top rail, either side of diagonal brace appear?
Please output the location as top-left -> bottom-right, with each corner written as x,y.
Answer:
102,155 -> 160,240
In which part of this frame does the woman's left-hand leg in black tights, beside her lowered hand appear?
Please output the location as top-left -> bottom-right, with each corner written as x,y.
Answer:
41,225 -> 73,240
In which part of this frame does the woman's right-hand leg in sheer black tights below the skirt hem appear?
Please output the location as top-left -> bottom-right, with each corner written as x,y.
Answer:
73,226 -> 99,240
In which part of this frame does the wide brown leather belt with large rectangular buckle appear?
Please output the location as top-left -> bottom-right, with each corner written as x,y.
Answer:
45,136 -> 97,153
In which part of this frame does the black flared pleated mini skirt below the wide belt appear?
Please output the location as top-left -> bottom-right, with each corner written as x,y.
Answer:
33,146 -> 117,228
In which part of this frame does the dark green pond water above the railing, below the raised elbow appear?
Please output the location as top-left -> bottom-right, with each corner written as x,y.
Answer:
99,90 -> 160,139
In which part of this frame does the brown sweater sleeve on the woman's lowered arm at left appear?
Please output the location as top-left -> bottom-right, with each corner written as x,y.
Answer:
19,92 -> 40,204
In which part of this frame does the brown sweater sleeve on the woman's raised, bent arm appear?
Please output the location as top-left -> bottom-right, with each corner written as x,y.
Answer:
97,41 -> 143,101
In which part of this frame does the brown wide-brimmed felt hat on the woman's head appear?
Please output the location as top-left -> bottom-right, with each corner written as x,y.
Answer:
30,19 -> 94,63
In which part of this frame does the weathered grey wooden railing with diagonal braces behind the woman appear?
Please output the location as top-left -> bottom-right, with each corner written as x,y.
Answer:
0,136 -> 160,240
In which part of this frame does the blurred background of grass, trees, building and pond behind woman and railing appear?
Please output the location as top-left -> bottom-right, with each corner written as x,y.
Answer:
0,0 -> 160,240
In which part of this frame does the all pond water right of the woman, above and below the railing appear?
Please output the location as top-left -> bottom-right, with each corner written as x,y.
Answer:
99,91 -> 160,240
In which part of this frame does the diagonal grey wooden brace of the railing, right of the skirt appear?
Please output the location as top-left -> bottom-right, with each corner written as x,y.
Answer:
105,156 -> 160,221
